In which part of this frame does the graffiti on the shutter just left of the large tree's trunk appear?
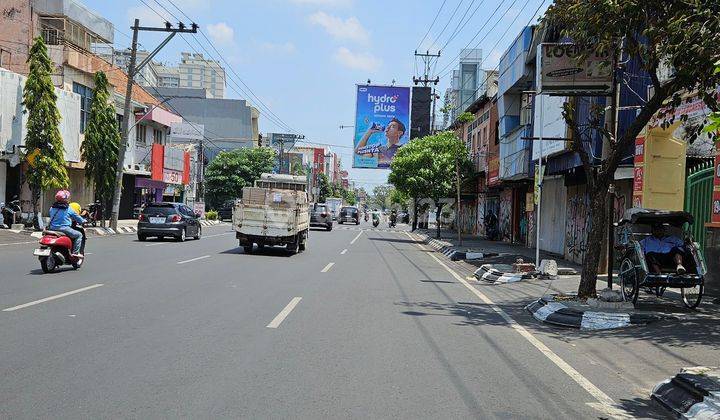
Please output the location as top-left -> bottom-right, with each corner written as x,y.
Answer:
565,186 -> 590,263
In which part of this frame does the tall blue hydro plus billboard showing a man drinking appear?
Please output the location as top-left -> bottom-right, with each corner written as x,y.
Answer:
353,85 -> 410,168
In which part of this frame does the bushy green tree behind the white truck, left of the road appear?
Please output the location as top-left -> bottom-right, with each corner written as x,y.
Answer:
205,147 -> 275,208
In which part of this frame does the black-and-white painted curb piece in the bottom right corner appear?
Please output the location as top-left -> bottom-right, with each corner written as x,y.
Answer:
650,366 -> 720,419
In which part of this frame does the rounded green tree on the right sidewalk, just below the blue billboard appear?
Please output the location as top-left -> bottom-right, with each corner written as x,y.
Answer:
388,131 -> 472,238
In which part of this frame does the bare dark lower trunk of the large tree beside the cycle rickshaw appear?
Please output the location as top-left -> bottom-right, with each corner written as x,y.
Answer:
578,184 -> 608,299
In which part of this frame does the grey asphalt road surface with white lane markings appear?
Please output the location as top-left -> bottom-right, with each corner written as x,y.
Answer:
0,223 -> 676,419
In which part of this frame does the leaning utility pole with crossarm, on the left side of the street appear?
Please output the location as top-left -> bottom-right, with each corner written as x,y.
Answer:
110,19 -> 198,229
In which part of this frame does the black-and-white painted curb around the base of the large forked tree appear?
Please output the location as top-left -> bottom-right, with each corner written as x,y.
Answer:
525,296 -> 671,331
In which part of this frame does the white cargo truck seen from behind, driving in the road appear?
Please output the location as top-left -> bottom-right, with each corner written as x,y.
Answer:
233,174 -> 310,254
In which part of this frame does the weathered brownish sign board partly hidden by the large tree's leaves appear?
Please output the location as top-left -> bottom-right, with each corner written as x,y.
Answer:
537,43 -> 613,96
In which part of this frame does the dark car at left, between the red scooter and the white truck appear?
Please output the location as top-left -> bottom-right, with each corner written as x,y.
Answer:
138,203 -> 202,242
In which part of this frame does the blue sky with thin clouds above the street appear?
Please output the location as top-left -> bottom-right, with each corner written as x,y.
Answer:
81,0 -> 549,190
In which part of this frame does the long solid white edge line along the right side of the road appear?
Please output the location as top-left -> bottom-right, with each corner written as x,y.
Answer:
405,232 -> 631,418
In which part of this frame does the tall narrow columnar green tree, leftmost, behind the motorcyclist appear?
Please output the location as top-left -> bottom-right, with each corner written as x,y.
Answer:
22,37 -> 70,226
